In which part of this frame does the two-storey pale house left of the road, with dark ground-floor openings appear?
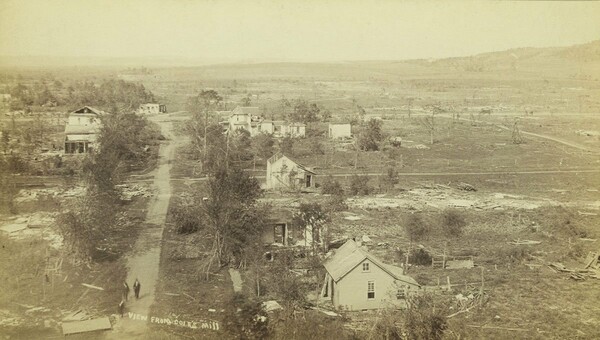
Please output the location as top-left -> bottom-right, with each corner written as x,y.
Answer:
65,106 -> 106,154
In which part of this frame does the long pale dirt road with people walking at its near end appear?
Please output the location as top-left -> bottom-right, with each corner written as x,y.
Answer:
107,116 -> 185,339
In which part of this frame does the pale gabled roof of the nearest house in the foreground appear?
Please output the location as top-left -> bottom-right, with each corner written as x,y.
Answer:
323,240 -> 419,286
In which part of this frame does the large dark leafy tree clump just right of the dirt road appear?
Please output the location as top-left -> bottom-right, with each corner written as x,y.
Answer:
173,166 -> 269,279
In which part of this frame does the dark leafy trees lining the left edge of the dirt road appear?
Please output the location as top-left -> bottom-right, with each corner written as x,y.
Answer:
58,113 -> 160,261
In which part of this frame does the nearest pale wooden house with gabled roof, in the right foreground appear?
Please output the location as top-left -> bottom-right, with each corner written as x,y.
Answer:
321,240 -> 421,311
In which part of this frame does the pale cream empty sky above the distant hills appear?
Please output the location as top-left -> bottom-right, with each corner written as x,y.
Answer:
0,0 -> 600,61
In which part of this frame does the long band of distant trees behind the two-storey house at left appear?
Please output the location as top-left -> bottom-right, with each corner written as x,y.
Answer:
10,79 -> 155,112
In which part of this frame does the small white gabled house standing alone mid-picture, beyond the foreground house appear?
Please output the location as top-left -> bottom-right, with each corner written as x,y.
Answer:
266,153 -> 316,190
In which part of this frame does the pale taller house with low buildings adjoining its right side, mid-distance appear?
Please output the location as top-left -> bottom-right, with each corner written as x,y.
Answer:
227,106 -> 306,137
